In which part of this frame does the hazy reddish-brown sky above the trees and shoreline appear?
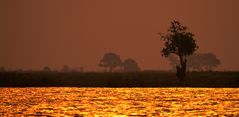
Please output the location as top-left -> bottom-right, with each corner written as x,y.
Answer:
0,0 -> 239,70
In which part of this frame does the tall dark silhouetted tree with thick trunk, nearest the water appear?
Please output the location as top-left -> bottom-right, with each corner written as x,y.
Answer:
160,21 -> 198,81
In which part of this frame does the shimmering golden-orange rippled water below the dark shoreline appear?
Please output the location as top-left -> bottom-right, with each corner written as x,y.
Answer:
0,88 -> 239,117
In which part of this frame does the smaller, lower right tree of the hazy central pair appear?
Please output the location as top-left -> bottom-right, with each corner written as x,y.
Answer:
123,58 -> 140,72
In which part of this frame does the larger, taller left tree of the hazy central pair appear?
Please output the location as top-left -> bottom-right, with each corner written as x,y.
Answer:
99,53 -> 122,72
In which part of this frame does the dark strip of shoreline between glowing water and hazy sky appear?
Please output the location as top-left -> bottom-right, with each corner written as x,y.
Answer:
0,71 -> 239,88
